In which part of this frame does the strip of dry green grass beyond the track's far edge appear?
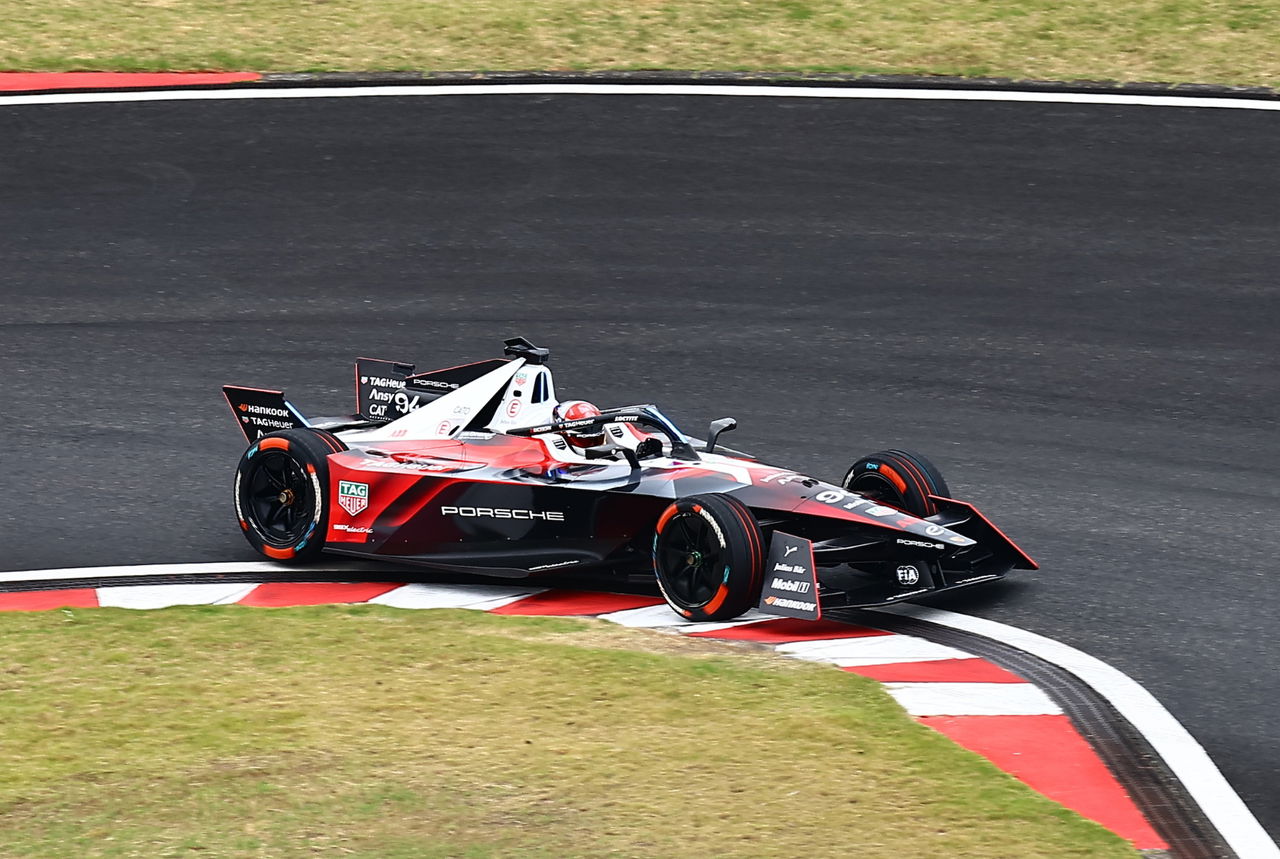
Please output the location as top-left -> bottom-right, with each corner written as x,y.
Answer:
0,0 -> 1280,86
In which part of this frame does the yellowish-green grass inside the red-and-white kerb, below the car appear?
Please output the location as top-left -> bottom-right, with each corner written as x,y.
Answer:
0,606 -> 1133,859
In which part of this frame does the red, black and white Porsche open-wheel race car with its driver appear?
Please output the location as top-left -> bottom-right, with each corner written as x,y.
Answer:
223,338 -> 1037,621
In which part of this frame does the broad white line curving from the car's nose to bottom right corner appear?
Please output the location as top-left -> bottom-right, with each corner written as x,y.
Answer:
874,606 -> 1280,859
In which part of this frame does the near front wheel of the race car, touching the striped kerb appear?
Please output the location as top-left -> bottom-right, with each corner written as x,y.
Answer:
653,494 -> 764,621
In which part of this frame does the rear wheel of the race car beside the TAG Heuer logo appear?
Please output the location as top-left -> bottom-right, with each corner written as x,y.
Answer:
236,428 -> 347,563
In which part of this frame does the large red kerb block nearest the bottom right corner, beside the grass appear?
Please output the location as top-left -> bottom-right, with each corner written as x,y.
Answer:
916,716 -> 1169,850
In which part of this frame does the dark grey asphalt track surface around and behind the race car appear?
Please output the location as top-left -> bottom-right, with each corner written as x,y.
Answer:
0,88 -> 1280,836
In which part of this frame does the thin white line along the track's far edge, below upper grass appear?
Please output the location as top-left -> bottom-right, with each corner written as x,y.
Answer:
0,83 -> 1280,110
